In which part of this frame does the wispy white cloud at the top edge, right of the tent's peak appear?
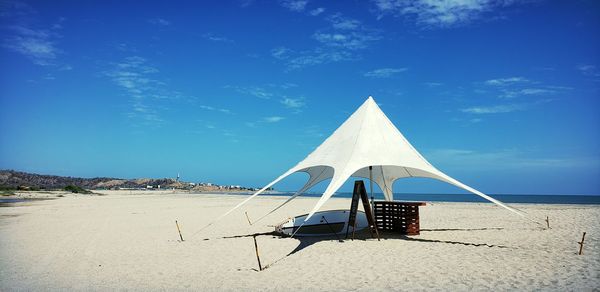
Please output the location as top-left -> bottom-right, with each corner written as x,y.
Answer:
373,0 -> 520,27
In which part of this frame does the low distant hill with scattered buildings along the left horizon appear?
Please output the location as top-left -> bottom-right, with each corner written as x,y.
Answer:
0,170 -> 255,191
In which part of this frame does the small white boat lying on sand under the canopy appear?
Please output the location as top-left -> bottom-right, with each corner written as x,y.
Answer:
275,210 -> 369,236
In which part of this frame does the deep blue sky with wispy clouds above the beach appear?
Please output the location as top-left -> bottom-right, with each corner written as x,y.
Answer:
0,0 -> 600,194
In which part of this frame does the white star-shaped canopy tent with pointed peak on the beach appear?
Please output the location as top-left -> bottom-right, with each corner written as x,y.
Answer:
204,97 -> 524,230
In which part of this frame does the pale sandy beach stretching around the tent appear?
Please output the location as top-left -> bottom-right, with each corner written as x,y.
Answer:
0,192 -> 600,291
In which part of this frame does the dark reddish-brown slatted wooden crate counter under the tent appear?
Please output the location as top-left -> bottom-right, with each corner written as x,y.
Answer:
374,201 -> 425,235
